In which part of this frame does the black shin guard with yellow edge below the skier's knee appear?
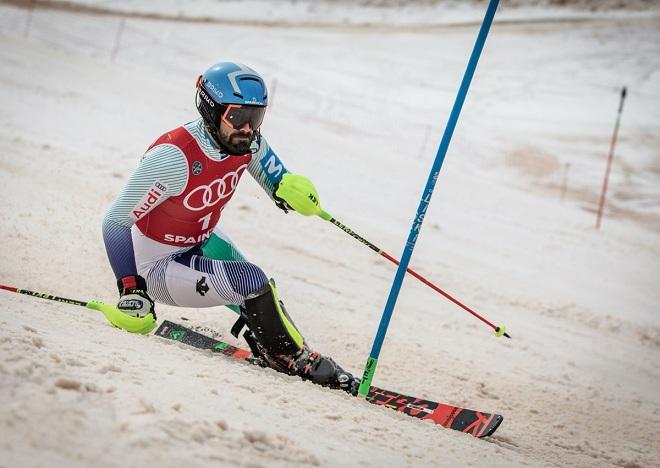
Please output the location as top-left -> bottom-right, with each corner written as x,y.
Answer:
244,279 -> 305,355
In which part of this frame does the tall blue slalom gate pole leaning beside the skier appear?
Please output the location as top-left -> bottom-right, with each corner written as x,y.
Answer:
358,0 -> 499,397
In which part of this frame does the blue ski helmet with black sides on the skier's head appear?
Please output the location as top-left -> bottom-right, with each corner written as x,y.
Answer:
195,62 -> 268,134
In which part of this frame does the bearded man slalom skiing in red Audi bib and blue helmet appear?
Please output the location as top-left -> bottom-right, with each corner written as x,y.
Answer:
103,62 -> 359,394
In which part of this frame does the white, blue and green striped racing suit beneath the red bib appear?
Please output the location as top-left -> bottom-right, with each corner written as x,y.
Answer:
103,119 -> 287,310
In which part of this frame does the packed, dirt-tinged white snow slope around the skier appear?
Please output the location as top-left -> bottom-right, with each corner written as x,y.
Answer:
0,1 -> 660,468
